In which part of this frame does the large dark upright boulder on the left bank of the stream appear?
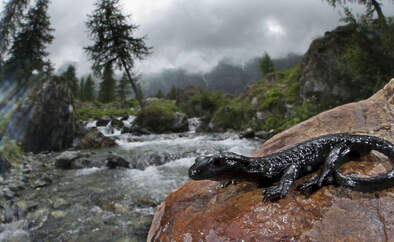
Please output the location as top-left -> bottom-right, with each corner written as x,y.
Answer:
5,77 -> 78,153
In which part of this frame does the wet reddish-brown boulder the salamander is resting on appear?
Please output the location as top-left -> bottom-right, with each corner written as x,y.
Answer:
148,79 -> 394,241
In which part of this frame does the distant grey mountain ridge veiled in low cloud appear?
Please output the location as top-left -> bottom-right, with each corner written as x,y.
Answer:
140,54 -> 302,96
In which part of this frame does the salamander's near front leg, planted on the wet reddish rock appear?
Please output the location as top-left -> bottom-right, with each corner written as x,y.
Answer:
262,164 -> 301,203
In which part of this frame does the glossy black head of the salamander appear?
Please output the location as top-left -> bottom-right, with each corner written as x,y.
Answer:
189,153 -> 246,181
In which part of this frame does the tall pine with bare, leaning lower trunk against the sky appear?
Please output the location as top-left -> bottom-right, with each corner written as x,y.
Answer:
85,0 -> 150,107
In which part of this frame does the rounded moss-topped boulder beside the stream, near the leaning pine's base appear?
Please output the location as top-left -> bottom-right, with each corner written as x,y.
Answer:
135,100 -> 180,133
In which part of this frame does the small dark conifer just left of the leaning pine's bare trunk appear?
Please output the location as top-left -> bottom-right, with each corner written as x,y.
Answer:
99,64 -> 116,103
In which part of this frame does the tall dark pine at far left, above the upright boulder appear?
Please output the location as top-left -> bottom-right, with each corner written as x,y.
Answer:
4,0 -> 53,80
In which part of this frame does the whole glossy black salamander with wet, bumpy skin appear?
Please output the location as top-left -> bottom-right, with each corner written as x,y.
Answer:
189,133 -> 394,202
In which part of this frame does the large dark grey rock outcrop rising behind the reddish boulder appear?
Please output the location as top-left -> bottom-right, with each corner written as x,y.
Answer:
299,25 -> 379,107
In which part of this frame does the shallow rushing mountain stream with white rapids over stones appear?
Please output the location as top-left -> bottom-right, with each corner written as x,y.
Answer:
0,120 -> 261,241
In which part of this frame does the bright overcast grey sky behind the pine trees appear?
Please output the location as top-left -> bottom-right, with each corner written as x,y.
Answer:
3,0 -> 394,74
